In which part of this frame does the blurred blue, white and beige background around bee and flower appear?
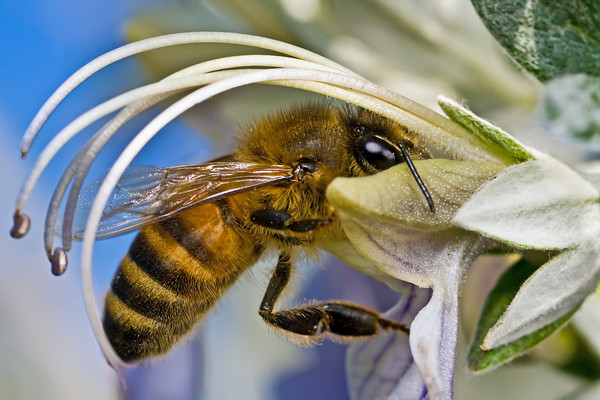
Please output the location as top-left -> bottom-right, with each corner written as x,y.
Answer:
0,0 -> 600,400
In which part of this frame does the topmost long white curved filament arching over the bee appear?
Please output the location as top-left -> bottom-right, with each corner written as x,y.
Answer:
21,32 -> 353,157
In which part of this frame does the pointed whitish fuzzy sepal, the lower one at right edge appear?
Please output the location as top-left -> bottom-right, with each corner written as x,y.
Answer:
483,243 -> 600,349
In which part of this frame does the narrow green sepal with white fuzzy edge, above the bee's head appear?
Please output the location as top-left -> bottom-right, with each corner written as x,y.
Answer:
438,96 -> 534,164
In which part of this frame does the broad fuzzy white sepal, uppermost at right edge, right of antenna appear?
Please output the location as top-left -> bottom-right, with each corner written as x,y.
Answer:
452,156 -> 600,249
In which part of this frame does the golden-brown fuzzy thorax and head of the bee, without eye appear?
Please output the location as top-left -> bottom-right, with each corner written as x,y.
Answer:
233,103 -> 431,250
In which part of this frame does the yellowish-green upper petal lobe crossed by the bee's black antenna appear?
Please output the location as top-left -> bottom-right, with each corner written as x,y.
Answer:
327,159 -> 505,231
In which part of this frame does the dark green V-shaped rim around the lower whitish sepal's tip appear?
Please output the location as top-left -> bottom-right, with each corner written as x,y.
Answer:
468,259 -> 579,372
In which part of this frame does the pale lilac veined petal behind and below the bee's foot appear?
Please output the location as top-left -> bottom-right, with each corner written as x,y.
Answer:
346,283 -> 431,400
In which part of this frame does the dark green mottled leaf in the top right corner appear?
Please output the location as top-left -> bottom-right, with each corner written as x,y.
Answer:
472,0 -> 600,82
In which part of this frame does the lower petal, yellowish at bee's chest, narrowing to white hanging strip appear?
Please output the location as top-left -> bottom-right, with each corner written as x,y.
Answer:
336,171 -> 488,400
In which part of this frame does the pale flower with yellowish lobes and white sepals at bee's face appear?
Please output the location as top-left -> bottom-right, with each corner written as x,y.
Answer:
328,98 -> 600,399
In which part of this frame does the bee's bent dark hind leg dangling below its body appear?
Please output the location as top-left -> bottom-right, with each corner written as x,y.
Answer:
258,254 -> 409,340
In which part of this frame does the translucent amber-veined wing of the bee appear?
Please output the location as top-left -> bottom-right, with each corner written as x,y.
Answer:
69,161 -> 293,239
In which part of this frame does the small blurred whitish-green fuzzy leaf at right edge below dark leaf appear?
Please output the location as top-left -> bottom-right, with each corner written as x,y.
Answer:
540,74 -> 600,148
